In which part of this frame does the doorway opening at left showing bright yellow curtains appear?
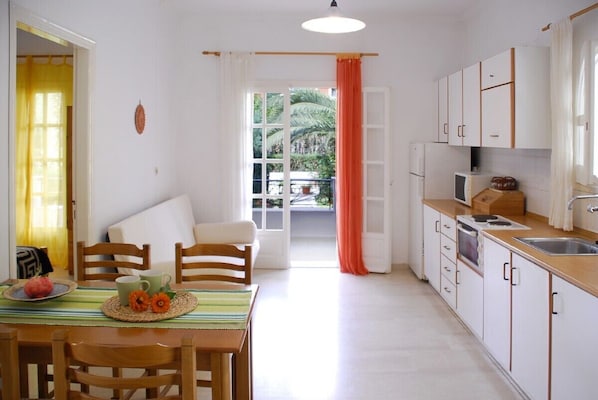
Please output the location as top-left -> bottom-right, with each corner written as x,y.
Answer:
15,24 -> 74,271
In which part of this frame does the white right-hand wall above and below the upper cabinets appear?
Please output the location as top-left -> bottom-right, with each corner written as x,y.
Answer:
463,0 -> 598,225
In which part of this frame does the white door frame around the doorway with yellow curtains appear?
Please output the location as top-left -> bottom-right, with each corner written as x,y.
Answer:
8,7 -> 95,278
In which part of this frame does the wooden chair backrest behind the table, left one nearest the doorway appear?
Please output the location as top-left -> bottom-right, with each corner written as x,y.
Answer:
77,242 -> 151,281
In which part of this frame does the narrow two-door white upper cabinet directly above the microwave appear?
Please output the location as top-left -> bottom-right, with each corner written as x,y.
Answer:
448,63 -> 481,146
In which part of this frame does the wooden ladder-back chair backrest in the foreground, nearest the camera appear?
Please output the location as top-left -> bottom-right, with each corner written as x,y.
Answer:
52,330 -> 197,400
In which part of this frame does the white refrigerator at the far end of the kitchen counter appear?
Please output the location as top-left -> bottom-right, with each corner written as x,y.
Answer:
409,143 -> 471,279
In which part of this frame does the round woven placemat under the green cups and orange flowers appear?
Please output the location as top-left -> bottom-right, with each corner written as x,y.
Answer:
102,291 -> 197,322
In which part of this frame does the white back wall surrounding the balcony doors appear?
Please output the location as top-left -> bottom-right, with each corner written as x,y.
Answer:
171,15 -> 461,263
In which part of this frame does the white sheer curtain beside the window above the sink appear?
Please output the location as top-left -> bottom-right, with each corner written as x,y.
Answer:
548,18 -> 574,231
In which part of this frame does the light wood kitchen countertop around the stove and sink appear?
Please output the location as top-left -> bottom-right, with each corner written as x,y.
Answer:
424,200 -> 598,297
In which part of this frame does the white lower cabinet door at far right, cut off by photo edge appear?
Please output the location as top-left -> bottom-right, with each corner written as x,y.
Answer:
551,275 -> 598,400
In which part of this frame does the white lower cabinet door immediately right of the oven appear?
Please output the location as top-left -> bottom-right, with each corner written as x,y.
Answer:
483,238 -> 511,371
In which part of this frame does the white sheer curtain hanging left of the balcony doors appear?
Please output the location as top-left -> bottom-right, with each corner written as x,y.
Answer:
220,52 -> 254,221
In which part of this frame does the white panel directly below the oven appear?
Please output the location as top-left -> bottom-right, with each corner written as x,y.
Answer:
456,260 -> 484,338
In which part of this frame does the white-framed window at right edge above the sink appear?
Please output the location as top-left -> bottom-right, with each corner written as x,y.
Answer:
574,41 -> 598,185
